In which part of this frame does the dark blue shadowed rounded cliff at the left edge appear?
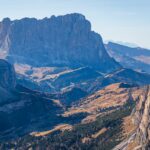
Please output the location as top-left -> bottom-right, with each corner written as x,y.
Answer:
0,59 -> 16,89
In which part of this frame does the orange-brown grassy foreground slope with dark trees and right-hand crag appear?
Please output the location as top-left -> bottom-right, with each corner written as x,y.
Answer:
1,83 -> 149,150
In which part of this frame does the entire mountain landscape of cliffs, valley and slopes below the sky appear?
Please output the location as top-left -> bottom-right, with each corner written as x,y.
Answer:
0,13 -> 150,150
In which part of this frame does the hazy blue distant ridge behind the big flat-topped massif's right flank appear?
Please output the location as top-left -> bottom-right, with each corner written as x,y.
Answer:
105,42 -> 150,73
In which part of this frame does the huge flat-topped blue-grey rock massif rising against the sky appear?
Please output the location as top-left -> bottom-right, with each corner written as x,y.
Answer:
0,14 -> 120,72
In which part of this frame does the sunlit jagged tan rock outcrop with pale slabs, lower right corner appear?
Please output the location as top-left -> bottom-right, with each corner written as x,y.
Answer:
114,86 -> 150,150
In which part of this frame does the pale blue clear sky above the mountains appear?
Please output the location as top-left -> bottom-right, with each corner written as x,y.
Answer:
0,0 -> 150,48
